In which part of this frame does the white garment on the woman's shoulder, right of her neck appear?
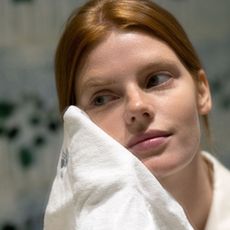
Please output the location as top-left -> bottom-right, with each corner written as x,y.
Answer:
202,152 -> 230,230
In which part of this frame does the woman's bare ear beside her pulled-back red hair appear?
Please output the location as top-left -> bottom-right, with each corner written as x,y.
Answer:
197,69 -> 212,115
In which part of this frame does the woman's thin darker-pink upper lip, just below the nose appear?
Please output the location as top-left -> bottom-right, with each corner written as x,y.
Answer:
127,130 -> 171,149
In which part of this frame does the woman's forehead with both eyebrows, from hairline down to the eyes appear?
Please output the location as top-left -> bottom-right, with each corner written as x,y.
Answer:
76,31 -> 192,97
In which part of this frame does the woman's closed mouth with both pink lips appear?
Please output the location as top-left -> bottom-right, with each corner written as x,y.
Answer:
127,130 -> 172,154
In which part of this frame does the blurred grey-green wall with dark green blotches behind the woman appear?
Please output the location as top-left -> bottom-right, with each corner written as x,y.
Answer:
0,0 -> 230,230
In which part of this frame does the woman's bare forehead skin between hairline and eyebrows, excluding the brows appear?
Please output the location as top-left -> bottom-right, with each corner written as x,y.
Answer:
79,30 -> 179,74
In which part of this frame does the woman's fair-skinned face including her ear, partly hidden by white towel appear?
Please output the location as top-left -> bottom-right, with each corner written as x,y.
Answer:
76,31 -> 211,179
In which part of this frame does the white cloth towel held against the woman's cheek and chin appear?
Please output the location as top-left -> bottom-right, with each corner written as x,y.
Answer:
44,106 -> 193,230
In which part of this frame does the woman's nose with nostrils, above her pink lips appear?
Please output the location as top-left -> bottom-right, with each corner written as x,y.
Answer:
124,88 -> 154,131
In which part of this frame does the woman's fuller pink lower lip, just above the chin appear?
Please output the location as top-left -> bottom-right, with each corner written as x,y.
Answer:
130,136 -> 169,154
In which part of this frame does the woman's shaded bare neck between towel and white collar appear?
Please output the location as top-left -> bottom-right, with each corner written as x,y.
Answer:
160,154 -> 212,230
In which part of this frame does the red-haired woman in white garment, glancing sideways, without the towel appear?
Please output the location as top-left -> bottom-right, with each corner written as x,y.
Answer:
45,0 -> 230,230
